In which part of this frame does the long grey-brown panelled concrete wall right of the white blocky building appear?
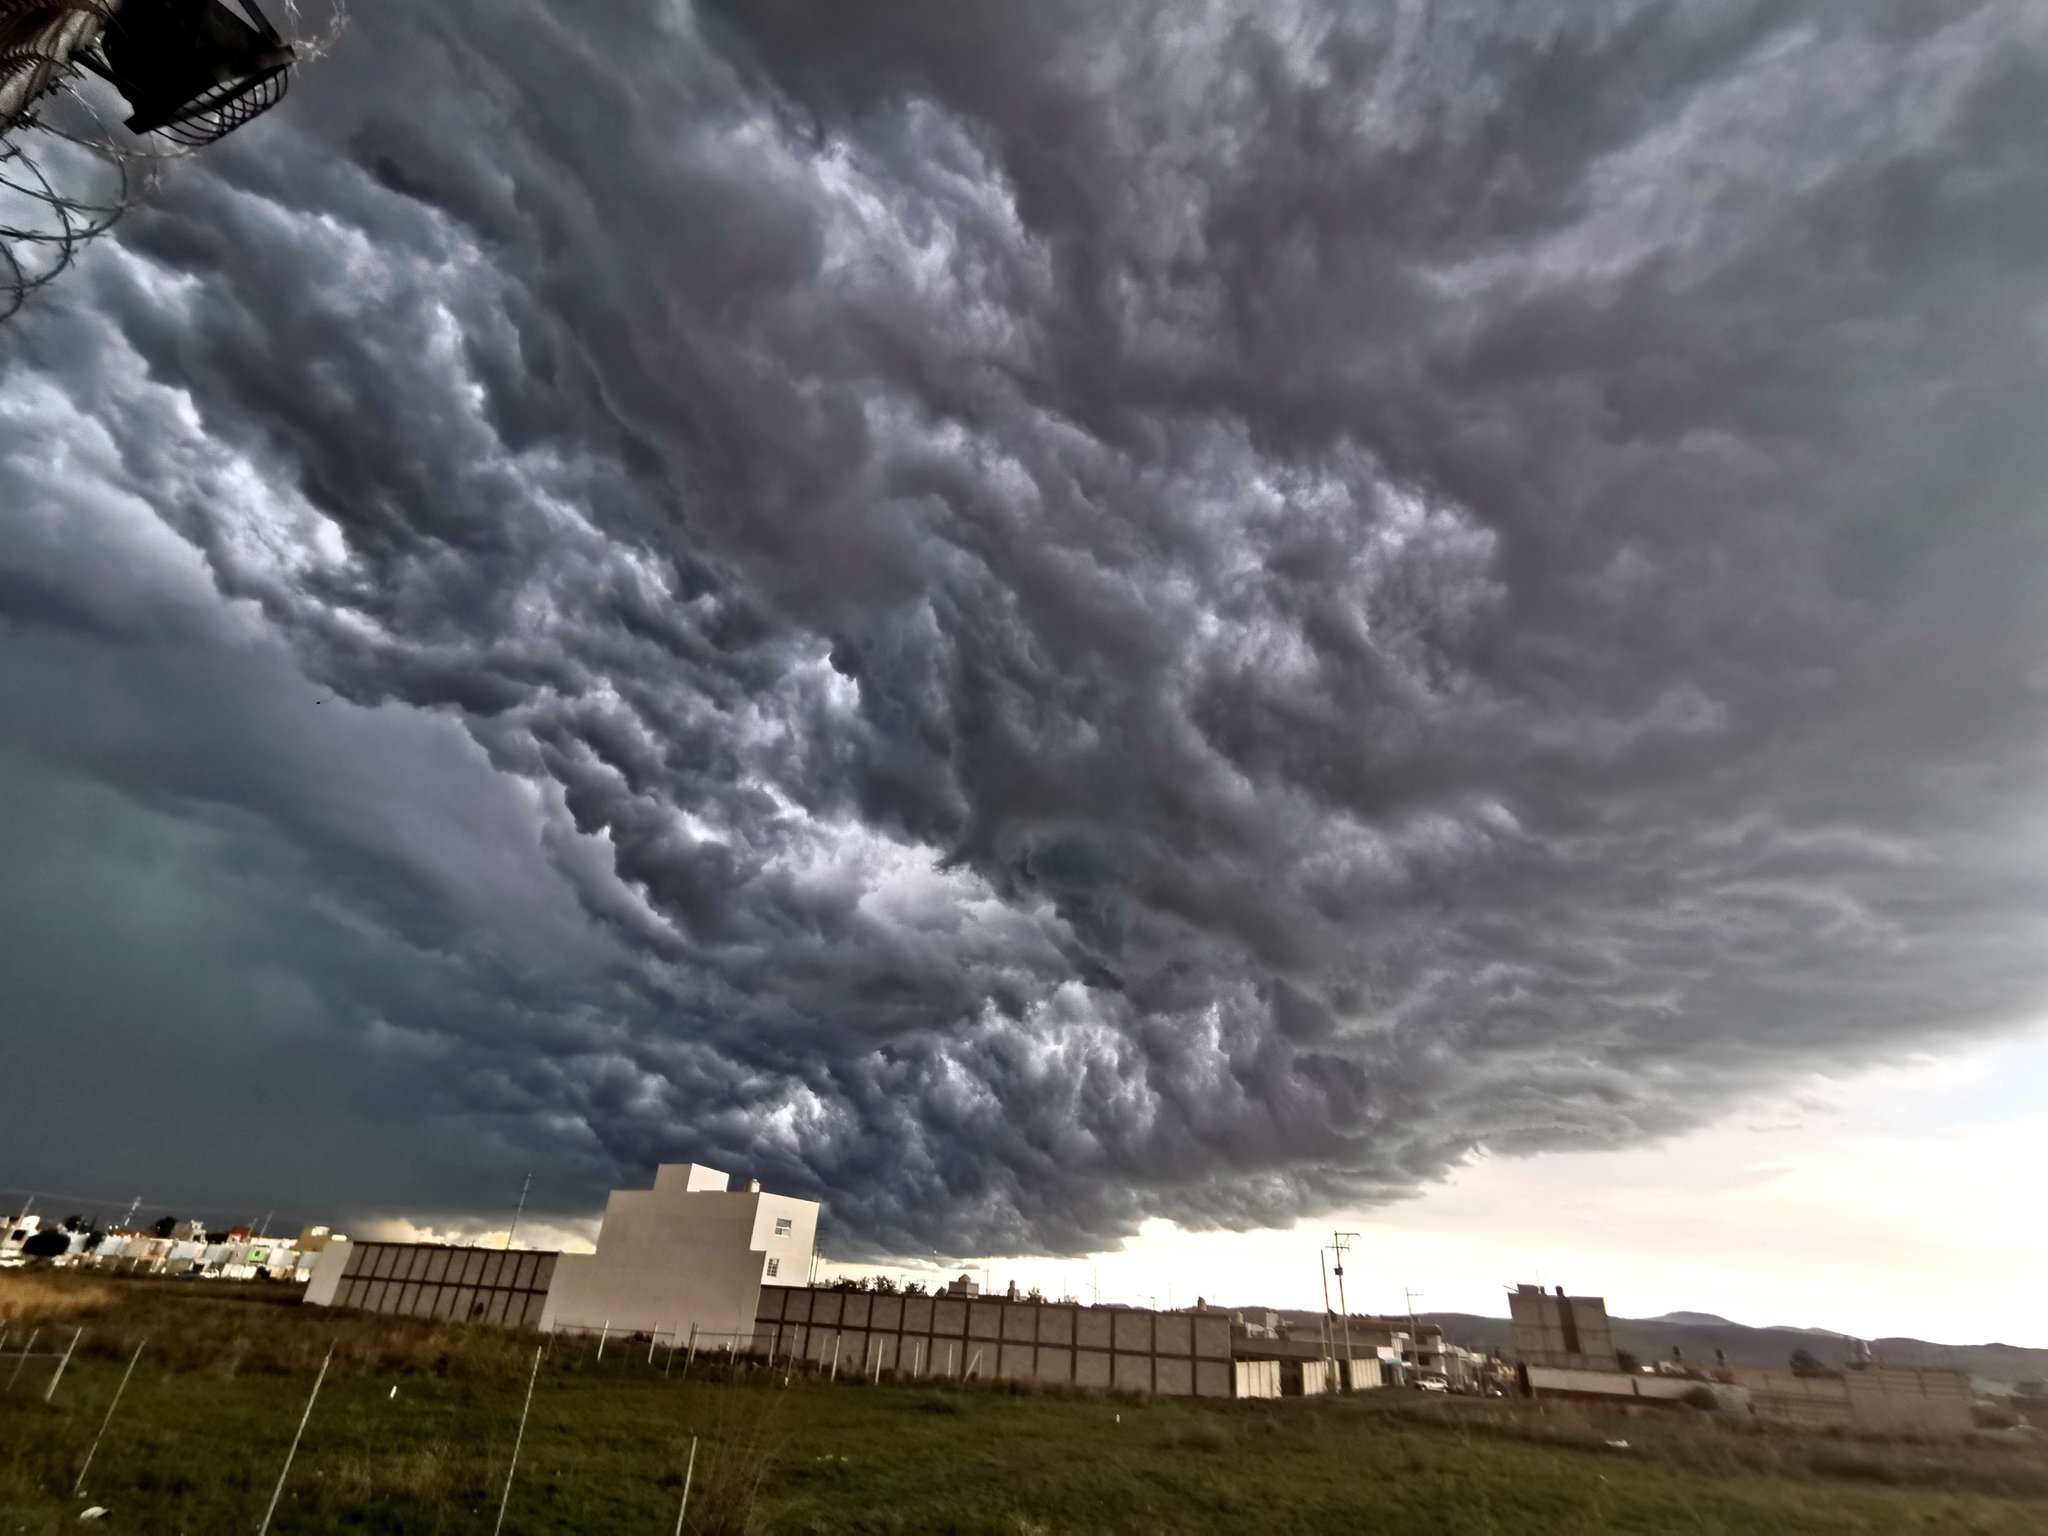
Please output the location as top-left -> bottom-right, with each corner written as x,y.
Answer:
752,1286 -> 1233,1397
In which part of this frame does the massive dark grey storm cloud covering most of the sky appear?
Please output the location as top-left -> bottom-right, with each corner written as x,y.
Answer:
0,0 -> 2048,1251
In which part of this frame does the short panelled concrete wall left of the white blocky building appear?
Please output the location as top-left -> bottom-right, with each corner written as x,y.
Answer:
305,1243 -> 555,1327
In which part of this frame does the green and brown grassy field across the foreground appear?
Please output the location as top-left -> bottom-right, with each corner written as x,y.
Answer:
0,1274 -> 2048,1536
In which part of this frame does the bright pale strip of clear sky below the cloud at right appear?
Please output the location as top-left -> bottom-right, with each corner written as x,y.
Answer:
802,1030 -> 2048,1350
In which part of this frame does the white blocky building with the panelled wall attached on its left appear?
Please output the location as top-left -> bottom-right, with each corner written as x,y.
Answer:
305,1163 -> 817,1348
